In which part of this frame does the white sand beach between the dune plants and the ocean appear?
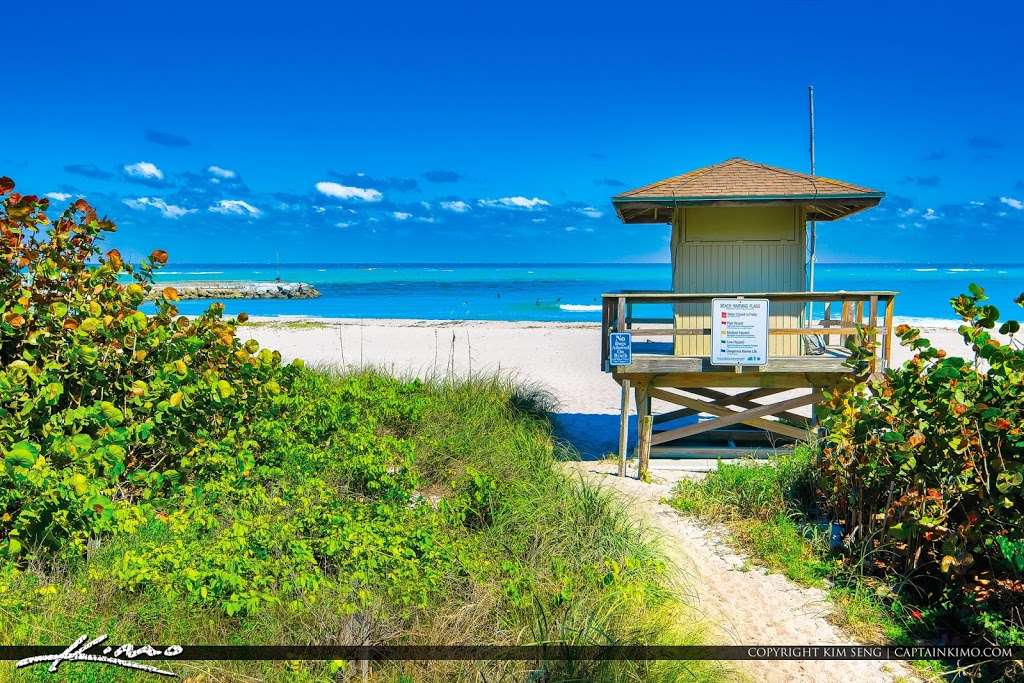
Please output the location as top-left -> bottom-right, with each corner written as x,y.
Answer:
241,317 -> 987,457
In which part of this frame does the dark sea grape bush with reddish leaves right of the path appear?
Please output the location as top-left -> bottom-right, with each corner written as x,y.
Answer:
820,285 -> 1024,643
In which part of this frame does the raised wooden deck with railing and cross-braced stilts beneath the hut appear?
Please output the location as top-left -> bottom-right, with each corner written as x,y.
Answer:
602,291 -> 896,471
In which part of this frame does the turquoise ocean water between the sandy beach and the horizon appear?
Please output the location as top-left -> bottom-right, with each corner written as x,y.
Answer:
148,263 -> 1024,322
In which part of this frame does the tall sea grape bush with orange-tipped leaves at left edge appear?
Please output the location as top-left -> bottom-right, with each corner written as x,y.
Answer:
0,177 -> 298,559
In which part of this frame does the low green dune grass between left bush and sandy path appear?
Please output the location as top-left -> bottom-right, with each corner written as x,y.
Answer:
0,372 -> 722,681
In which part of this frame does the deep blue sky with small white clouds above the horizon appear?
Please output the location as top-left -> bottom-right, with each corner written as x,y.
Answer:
8,0 -> 1024,262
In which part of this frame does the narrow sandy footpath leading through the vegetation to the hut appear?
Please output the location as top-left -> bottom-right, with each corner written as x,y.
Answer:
565,462 -> 921,683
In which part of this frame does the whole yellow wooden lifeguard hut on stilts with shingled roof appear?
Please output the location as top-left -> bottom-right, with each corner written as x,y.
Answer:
601,158 -> 896,471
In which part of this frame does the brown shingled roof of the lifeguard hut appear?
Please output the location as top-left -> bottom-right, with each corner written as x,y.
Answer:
611,157 -> 885,223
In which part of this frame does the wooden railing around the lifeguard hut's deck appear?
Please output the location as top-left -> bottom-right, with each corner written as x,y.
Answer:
601,291 -> 898,371
